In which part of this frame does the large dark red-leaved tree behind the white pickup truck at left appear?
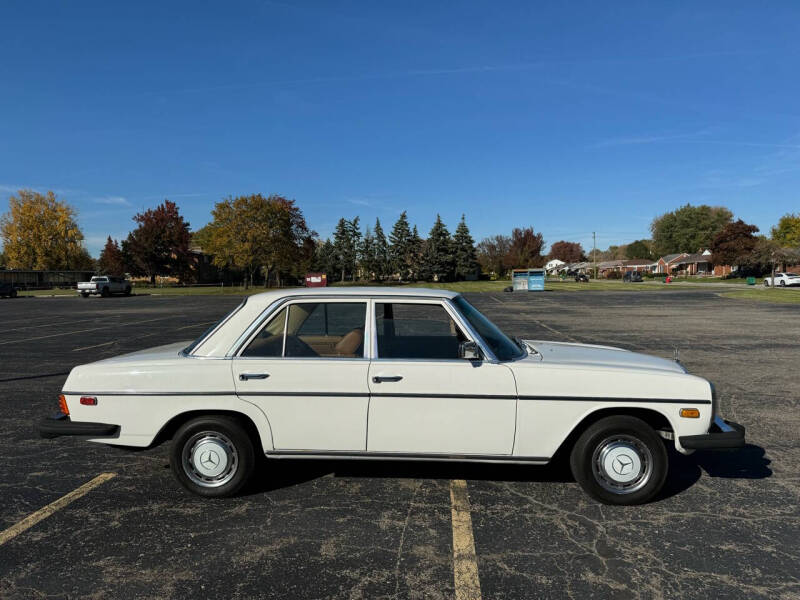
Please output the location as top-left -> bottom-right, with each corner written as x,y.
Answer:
122,200 -> 191,283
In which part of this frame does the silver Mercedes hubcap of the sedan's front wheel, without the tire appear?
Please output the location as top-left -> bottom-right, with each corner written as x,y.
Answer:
592,435 -> 653,494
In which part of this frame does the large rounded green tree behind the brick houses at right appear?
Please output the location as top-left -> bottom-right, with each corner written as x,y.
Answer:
650,204 -> 733,256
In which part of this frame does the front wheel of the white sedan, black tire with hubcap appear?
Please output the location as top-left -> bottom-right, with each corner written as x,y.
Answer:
569,415 -> 669,505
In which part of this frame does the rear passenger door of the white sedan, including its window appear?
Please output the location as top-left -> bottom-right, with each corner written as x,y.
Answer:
233,300 -> 369,452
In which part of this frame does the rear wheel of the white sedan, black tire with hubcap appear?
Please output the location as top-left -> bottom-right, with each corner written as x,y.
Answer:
169,415 -> 255,498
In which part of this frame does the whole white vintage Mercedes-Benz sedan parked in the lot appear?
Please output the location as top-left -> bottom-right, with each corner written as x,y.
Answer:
40,288 -> 744,504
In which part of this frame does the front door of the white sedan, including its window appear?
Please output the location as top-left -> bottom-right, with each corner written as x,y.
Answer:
367,300 -> 517,456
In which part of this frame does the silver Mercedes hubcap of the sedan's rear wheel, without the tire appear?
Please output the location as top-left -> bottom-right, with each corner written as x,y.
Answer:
183,431 -> 239,487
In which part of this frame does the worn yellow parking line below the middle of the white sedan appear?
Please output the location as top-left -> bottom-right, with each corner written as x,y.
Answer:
450,479 -> 481,600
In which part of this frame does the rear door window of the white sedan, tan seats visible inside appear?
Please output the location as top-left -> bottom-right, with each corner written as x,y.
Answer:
242,302 -> 367,358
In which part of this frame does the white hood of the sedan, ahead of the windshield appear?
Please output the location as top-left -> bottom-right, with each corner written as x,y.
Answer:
523,340 -> 686,373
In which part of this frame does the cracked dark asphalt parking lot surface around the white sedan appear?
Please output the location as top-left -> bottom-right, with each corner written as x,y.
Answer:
0,290 -> 800,599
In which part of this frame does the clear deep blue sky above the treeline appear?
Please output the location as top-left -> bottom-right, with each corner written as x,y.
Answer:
0,0 -> 800,255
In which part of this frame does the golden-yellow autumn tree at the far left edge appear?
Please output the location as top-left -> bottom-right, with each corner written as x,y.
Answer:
0,190 -> 93,270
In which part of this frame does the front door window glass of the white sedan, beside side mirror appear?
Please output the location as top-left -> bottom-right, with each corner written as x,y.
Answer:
375,302 -> 467,359
